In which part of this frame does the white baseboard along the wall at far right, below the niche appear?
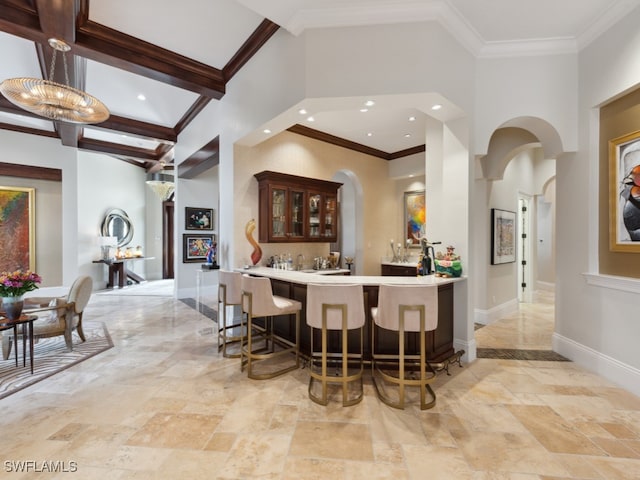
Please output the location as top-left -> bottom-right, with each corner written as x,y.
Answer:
551,333 -> 640,396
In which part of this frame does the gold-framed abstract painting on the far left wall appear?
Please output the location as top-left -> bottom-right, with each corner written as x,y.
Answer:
0,187 -> 36,272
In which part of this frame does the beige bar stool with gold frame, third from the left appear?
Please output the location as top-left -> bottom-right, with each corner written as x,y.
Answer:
307,284 -> 365,407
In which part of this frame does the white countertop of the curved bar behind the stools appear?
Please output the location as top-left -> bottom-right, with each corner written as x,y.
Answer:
236,267 -> 466,285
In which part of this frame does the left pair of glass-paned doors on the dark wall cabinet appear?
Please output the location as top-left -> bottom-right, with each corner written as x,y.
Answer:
268,185 -> 304,242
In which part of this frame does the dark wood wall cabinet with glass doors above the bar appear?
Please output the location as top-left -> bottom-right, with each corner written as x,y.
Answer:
254,171 -> 342,243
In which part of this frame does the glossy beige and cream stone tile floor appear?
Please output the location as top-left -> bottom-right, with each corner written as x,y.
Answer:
0,286 -> 640,480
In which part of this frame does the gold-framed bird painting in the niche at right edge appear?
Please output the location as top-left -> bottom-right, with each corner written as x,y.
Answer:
609,131 -> 640,253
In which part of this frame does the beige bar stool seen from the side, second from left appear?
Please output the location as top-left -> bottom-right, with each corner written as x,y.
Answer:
240,274 -> 302,380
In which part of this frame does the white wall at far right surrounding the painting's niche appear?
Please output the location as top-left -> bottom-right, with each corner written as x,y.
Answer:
554,4 -> 640,394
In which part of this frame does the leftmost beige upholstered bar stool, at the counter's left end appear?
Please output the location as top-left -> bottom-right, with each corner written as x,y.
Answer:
213,270 -> 244,358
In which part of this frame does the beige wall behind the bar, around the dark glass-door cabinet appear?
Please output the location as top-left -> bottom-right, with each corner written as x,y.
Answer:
233,132 -> 399,275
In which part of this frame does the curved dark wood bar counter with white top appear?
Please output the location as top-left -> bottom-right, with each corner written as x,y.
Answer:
237,267 -> 466,363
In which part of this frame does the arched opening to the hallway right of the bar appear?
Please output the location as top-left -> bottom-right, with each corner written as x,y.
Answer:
476,117 -> 562,356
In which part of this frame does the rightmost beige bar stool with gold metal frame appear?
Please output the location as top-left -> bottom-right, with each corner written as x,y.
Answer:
371,285 -> 438,410
